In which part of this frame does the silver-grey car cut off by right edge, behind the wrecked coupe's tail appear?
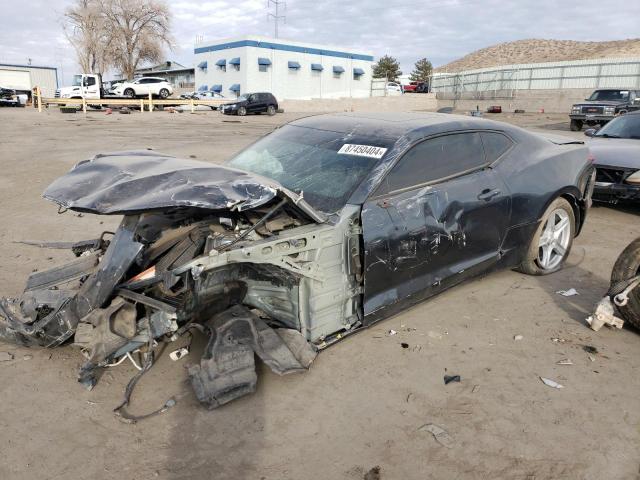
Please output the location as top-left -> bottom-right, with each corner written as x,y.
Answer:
585,112 -> 640,203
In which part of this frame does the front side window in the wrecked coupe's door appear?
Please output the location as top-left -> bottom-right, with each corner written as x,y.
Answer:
380,132 -> 487,192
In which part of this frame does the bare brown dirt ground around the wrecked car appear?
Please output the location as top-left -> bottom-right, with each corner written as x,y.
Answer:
0,109 -> 640,480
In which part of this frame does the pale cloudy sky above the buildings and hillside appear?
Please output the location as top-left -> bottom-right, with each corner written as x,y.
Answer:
0,0 -> 640,84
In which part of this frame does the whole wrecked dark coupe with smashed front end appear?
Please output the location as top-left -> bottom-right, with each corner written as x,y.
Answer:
0,114 -> 594,408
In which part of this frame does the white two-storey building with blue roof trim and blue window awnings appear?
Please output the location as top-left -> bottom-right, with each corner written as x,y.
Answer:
194,36 -> 373,100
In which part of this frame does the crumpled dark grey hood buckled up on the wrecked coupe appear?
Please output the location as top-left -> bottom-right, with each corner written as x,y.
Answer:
43,150 -> 325,222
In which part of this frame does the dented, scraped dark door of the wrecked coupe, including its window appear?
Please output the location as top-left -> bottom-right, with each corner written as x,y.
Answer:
362,132 -> 510,323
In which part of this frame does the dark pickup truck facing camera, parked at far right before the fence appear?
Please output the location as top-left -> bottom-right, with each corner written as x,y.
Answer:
569,88 -> 640,132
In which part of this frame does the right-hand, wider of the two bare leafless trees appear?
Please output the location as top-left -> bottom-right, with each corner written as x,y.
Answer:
97,0 -> 173,78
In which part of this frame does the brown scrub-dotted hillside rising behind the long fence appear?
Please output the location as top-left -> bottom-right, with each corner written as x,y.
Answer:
435,38 -> 640,72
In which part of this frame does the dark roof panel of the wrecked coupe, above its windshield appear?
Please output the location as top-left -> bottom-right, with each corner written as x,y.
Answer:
290,112 -> 515,140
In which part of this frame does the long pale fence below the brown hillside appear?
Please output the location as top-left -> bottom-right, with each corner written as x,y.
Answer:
431,58 -> 640,99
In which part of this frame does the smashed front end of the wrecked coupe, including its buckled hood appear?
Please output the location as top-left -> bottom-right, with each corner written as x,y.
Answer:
0,152 -> 362,417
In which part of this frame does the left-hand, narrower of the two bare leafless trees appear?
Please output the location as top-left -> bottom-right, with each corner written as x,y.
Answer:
62,0 -> 110,74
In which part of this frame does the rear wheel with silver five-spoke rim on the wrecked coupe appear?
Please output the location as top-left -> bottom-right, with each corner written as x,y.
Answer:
516,198 -> 576,275
